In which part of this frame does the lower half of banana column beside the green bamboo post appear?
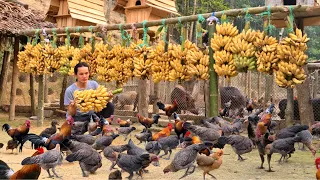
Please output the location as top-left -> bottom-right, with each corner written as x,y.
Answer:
213,50 -> 238,80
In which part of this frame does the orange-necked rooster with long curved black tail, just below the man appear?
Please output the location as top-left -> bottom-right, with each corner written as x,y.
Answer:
20,116 -> 74,151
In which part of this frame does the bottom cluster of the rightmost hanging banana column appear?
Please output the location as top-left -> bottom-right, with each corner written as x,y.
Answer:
276,61 -> 307,88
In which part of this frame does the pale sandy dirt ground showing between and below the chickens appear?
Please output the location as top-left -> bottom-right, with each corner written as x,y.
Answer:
0,113 -> 319,180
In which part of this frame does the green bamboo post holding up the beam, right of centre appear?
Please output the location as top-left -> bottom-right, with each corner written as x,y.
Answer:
208,22 -> 219,117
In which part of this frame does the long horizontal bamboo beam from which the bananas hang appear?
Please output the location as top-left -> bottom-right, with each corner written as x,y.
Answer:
19,5 -> 312,36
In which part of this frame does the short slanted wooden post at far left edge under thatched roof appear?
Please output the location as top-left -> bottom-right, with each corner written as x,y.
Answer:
0,51 -> 11,103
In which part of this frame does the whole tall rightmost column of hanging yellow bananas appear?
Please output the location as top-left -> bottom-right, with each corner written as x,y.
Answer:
276,28 -> 309,88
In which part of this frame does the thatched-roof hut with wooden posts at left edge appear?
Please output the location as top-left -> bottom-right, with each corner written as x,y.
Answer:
0,0 -> 55,120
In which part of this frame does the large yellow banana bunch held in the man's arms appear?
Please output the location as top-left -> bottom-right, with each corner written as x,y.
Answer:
74,85 -> 112,112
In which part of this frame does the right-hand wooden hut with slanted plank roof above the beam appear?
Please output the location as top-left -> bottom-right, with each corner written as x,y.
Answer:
113,0 -> 179,36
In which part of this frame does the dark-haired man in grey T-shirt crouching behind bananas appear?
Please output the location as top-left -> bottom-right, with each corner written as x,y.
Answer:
64,62 -> 114,122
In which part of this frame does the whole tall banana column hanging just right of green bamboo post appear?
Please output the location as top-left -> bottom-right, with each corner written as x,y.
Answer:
211,22 -> 239,81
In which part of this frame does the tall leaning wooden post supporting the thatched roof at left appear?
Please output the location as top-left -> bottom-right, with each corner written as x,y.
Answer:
9,37 -> 19,121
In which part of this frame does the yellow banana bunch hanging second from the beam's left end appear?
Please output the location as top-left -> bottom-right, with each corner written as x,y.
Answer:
42,44 -> 61,75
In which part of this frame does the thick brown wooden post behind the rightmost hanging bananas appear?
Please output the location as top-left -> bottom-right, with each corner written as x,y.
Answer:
296,19 -> 318,126
